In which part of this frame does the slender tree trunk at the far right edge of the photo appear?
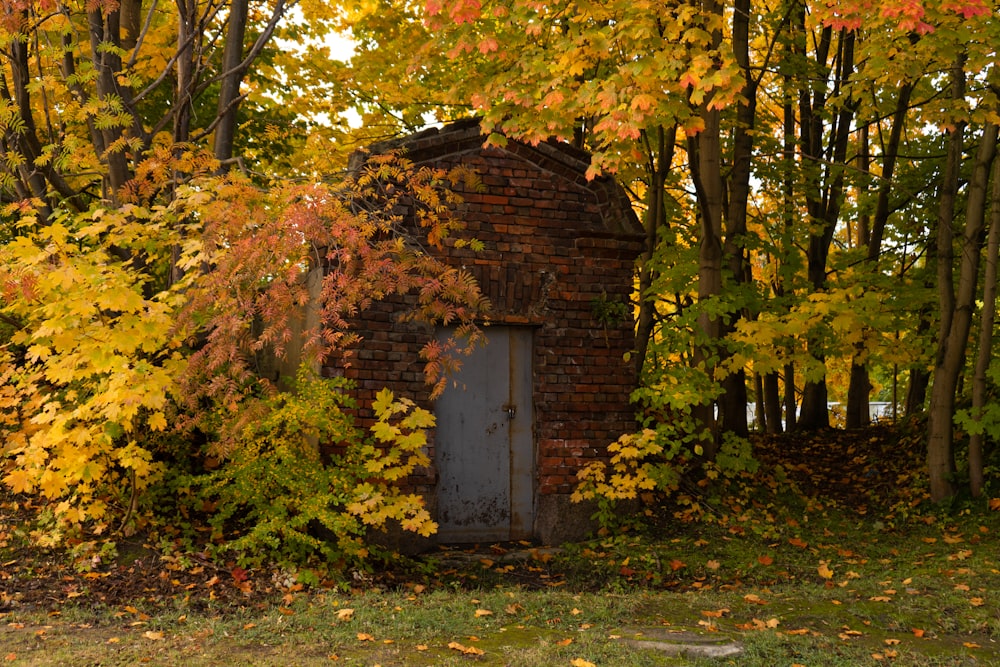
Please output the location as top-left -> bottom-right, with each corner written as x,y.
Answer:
969,157 -> 1000,498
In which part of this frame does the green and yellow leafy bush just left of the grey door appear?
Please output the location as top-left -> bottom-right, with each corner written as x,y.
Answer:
189,371 -> 436,570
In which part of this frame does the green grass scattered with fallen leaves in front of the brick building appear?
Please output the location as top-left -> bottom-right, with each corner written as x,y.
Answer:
0,509 -> 1000,667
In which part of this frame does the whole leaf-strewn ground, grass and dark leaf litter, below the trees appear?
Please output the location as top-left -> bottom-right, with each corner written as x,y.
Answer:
0,428 -> 1000,667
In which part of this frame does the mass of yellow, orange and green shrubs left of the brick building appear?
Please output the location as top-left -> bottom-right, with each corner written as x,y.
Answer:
0,145 -> 486,557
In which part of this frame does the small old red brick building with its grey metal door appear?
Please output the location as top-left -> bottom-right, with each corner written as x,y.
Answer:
340,122 -> 643,543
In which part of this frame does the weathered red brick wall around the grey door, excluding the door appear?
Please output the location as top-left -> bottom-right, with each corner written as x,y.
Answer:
330,128 -> 641,506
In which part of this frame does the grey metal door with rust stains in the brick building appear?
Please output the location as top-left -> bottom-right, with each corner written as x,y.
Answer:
435,327 -> 535,542
